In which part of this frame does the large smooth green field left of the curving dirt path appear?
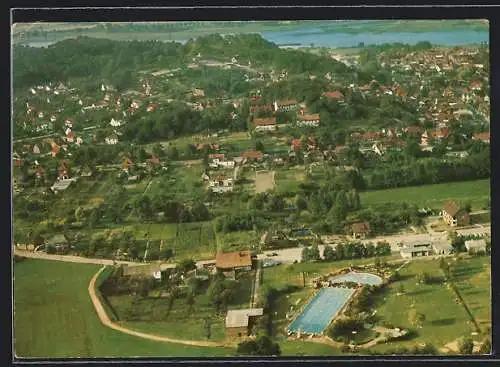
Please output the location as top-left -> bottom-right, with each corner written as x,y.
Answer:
14,259 -> 234,358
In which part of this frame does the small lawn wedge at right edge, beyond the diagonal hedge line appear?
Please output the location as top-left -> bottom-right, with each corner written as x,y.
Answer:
453,256 -> 491,332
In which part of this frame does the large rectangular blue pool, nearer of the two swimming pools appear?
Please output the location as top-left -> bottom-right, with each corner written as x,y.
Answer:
288,287 -> 354,334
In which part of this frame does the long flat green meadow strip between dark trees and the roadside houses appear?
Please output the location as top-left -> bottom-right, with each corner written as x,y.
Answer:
360,180 -> 490,210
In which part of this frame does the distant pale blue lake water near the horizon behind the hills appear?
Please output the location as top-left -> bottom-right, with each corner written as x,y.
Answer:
18,25 -> 489,48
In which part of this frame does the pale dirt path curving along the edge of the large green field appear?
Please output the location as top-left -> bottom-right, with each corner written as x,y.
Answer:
89,266 -> 230,347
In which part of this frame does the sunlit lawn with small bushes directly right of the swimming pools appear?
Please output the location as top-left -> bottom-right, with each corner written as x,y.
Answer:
372,260 -> 480,351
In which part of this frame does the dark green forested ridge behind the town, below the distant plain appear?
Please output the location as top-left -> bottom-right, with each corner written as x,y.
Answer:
13,34 -> 348,89
